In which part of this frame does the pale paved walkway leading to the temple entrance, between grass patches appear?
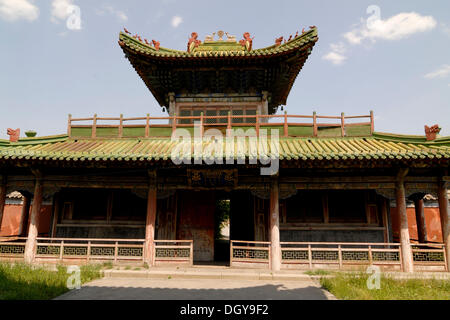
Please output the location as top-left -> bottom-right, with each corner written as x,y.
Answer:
56,277 -> 335,300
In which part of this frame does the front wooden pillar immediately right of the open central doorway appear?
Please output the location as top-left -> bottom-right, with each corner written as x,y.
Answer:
270,179 -> 281,271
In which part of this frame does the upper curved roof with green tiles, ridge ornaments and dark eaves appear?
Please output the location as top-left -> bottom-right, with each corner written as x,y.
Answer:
119,26 -> 318,114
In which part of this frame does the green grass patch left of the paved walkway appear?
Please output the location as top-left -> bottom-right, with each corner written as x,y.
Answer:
0,263 -> 102,300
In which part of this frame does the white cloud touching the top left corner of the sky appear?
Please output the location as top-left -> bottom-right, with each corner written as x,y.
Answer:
0,0 -> 39,21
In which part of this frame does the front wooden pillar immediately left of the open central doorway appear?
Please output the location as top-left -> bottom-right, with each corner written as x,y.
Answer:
145,185 -> 156,266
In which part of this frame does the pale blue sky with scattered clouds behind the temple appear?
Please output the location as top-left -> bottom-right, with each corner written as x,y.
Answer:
0,0 -> 450,139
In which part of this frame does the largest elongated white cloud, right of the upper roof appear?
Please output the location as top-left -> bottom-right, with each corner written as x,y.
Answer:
344,12 -> 437,44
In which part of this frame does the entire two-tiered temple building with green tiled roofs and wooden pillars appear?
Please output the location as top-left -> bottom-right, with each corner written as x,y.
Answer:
0,26 -> 450,272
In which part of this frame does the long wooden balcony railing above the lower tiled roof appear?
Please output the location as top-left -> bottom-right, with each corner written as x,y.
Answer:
67,111 -> 374,138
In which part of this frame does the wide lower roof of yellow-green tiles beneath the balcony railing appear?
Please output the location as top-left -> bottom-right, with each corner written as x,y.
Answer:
0,132 -> 450,166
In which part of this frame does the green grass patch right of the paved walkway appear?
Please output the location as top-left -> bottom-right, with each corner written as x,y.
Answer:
320,272 -> 450,300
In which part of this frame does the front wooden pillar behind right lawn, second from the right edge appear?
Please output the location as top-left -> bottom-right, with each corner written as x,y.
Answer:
395,169 -> 414,272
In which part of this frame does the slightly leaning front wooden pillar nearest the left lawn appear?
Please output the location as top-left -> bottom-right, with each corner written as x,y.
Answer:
25,173 -> 43,263
